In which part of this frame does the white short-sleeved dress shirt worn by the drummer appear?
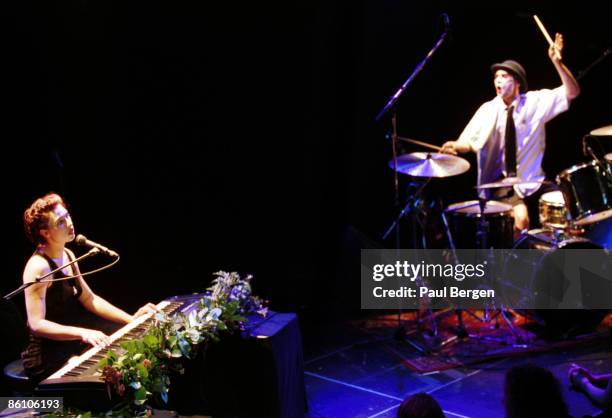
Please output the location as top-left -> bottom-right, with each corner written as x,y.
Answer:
457,86 -> 569,198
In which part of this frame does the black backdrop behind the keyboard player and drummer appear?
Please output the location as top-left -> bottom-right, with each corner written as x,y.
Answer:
0,0 -> 612,317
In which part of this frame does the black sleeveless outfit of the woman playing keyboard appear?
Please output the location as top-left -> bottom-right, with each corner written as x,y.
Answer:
21,253 -> 87,382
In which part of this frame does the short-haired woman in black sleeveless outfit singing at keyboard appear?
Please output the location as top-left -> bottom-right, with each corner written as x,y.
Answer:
21,193 -> 155,382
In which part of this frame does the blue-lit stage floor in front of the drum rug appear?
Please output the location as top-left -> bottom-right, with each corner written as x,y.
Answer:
303,316 -> 612,418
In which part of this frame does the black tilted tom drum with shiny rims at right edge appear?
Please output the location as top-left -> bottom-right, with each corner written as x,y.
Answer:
557,161 -> 612,225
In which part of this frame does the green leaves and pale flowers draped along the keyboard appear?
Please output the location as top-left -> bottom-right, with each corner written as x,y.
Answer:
100,271 -> 267,416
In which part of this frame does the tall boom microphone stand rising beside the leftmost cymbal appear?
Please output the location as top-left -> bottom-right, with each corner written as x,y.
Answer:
376,26 -> 448,352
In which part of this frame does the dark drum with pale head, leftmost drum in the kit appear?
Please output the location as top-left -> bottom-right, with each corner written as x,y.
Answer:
444,200 -> 514,248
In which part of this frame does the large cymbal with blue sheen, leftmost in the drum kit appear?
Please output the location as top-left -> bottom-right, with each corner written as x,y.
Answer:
389,152 -> 470,178
